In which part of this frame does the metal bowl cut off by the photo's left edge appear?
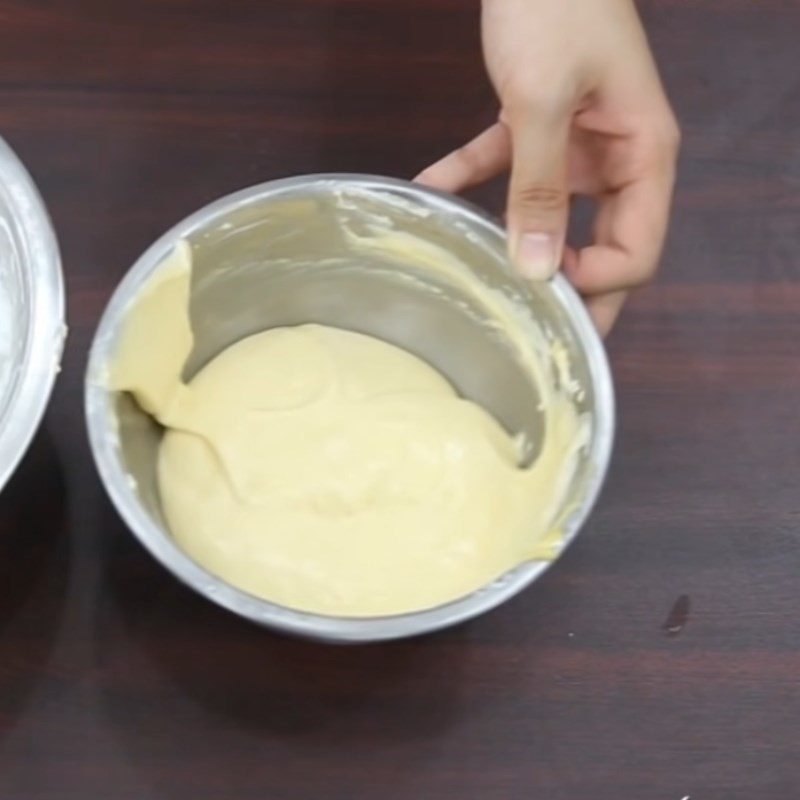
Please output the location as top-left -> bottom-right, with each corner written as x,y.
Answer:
0,139 -> 66,489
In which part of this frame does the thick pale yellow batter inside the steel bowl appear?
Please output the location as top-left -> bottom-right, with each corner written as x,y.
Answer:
111,234 -> 581,616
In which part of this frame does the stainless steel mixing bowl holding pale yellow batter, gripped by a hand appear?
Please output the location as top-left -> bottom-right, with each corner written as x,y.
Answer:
86,175 -> 614,642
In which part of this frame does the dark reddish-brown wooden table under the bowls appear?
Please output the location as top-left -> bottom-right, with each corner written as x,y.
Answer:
0,0 -> 800,800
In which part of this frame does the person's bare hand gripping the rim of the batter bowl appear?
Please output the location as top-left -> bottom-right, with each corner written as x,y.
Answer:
417,0 -> 679,334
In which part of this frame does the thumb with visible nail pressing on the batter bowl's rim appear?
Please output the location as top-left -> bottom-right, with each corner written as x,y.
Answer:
508,109 -> 570,280
